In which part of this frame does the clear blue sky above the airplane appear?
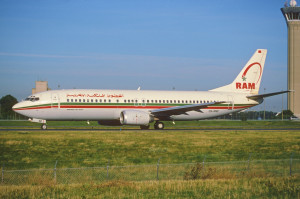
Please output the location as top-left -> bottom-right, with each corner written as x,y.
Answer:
0,0 -> 287,111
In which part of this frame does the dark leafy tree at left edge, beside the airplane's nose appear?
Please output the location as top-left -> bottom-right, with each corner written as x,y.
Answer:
0,95 -> 18,119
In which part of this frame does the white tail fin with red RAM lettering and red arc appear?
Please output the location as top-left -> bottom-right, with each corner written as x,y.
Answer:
210,49 -> 267,95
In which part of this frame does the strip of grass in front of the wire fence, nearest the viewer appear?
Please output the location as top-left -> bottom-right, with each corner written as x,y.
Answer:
0,178 -> 300,198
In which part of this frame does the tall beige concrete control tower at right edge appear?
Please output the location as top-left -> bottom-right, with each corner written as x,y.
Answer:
281,0 -> 300,118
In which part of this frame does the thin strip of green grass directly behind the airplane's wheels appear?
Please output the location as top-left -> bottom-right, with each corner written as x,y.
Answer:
0,120 -> 300,129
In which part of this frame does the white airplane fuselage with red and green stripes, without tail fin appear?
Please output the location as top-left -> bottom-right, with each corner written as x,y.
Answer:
13,89 -> 261,121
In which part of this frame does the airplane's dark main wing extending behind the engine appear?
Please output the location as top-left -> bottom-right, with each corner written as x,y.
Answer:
150,102 -> 225,118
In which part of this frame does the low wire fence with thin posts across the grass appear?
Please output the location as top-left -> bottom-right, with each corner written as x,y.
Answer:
1,157 -> 300,185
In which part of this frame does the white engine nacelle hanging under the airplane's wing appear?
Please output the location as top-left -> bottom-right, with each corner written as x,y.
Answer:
120,110 -> 154,125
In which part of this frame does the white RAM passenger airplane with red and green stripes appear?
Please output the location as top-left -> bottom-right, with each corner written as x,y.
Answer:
13,49 -> 290,130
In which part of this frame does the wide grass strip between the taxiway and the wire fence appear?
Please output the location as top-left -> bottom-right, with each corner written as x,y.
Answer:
0,130 -> 300,169
